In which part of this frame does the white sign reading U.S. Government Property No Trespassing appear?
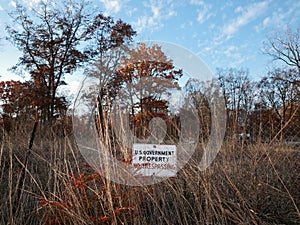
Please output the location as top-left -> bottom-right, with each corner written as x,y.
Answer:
132,144 -> 177,177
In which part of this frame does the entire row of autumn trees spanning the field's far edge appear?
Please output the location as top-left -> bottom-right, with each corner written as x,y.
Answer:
0,0 -> 300,144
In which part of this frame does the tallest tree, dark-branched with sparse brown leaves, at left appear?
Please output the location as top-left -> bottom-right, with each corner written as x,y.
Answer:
6,0 -> 135,121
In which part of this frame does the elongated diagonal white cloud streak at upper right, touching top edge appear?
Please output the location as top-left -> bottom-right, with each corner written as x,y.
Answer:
223,0 -> 269,36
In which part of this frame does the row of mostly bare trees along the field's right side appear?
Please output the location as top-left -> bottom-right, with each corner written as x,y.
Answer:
186,69 -> 300,142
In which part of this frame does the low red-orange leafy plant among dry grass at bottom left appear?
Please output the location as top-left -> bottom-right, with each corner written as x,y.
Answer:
38,168 -> 143,224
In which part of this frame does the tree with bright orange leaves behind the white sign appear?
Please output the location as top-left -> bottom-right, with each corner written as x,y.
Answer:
117,43 -> 183,136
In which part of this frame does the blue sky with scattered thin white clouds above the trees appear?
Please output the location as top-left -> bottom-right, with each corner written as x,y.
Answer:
0,0 -> 300,87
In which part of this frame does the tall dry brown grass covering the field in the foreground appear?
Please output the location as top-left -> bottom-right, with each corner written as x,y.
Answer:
0,118 -> 300,225
